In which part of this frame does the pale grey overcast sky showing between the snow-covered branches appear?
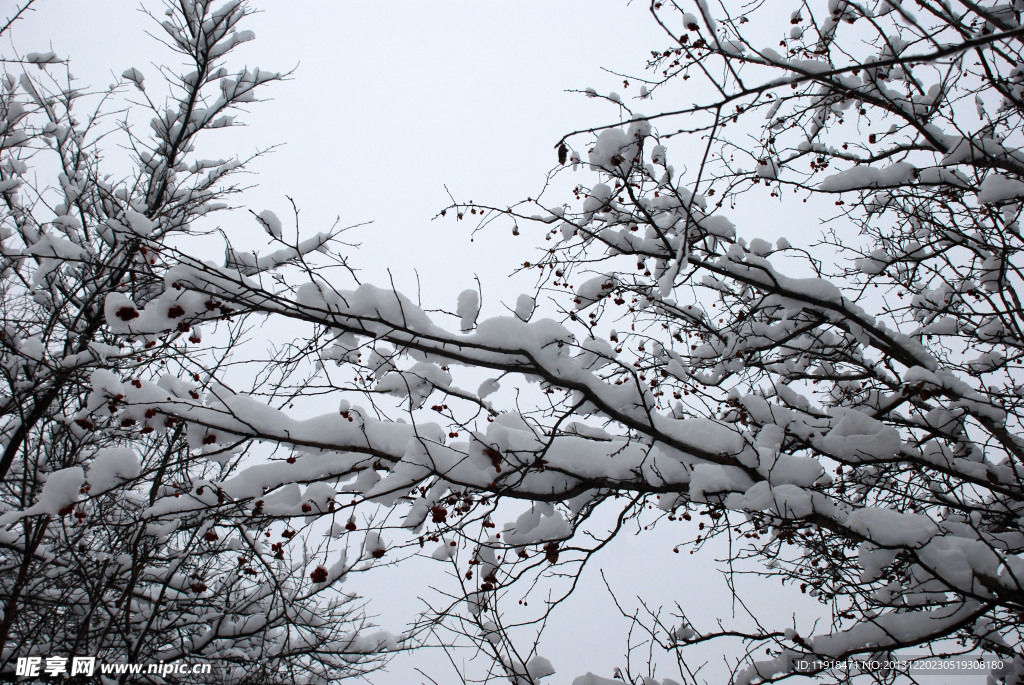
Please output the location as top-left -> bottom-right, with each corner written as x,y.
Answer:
3,5 -> 872,684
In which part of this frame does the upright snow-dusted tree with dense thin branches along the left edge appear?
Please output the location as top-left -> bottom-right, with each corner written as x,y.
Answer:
0,2 -> 381,683
